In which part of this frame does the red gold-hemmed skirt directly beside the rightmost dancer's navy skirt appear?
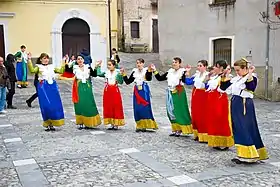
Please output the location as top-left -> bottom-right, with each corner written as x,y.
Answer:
206,90 -> 234,147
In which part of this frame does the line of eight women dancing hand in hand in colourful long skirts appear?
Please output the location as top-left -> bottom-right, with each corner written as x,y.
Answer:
15,50 -> 268,164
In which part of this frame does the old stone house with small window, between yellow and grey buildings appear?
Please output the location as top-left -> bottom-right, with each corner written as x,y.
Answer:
118,0 -> 159,52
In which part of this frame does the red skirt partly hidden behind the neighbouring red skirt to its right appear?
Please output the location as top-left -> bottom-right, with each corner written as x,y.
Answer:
191,88 -> 207,142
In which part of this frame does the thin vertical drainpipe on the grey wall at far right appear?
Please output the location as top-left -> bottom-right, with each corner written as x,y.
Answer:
264,0 -> 270,99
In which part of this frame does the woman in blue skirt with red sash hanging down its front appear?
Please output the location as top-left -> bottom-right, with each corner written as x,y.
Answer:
121,58 -> 158,132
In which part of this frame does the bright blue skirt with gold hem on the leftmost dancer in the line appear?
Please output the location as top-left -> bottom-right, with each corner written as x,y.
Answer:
37,80 -> 64,127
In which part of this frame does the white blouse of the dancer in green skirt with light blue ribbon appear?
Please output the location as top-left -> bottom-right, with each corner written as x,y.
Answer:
167,68 -> 185,91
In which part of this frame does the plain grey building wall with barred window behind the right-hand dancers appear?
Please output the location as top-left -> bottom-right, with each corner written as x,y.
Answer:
158,0 -> 280,101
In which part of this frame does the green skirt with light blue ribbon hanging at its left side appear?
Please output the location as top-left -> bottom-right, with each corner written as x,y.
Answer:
167,86 -> 193,134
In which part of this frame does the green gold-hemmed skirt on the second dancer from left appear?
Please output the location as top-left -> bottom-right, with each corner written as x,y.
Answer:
74,81 -> 101,128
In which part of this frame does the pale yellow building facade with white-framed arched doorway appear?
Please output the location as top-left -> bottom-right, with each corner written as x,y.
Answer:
0,0 -> 118,66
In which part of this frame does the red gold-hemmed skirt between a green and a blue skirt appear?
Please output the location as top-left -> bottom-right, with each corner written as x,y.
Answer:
103,85 -> 125,126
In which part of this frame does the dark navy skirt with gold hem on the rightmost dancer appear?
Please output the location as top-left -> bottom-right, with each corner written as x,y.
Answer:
231,95 -> 268,160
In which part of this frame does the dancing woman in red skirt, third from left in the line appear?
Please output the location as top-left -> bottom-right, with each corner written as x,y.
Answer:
97,60 -> 125,130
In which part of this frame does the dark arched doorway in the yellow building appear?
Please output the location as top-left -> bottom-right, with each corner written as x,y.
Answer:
62,18 -> 90,55
